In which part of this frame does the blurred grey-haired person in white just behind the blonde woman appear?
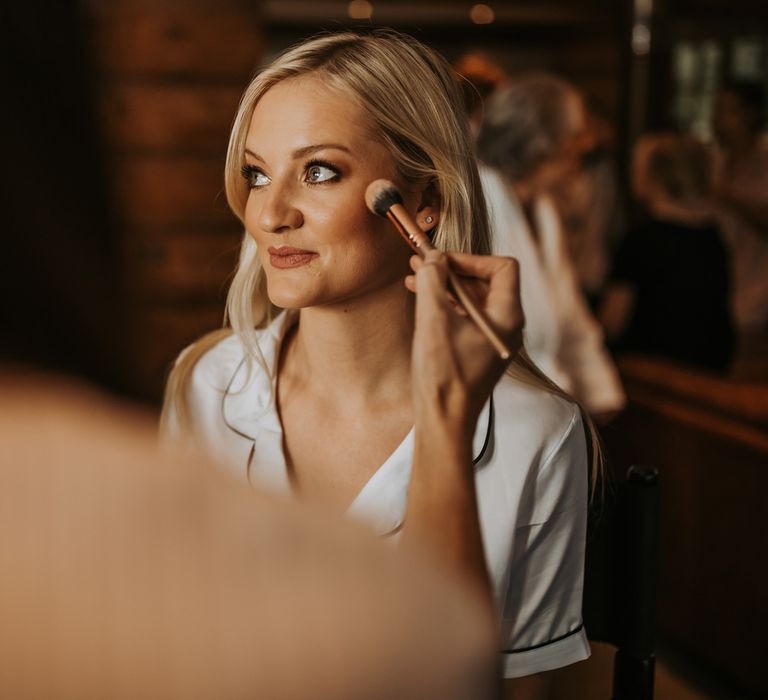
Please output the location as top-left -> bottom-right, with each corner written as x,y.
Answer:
477,74 -> 625,420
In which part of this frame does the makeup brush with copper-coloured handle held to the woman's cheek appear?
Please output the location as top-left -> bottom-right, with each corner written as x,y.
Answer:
365,180 -> 512,360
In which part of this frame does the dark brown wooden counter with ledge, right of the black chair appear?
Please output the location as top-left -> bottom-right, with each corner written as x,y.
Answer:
606,358 -> 768,697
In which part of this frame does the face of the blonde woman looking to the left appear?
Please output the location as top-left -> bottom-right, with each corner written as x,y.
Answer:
243,76 -> 426,308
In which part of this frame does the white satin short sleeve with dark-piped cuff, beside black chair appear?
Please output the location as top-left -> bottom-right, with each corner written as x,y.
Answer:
501,406 -> 590,678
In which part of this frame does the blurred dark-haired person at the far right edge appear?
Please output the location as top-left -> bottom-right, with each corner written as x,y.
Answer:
712,82 -> 768,378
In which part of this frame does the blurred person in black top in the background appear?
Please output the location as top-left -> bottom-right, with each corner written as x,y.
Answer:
599,134 -> 733,373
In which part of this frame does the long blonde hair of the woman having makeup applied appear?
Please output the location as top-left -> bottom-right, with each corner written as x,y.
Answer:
164,30 -> 594,492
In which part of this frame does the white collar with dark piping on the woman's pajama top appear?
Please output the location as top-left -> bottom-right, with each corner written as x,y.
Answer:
221,311 -> 493,536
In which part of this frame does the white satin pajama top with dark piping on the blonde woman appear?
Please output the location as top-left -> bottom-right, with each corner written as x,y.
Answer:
165,313 -> 589,678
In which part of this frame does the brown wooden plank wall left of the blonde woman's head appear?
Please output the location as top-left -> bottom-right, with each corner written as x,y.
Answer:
83,0 -> 263,402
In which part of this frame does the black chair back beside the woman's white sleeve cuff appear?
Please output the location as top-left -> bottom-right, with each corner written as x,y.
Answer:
583,467 -> 659,700
